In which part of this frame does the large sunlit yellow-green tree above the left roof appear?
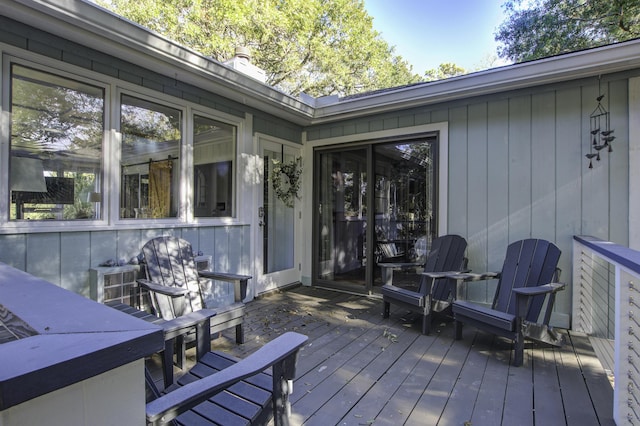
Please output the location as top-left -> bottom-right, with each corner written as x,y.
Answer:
98,0 -> 420,96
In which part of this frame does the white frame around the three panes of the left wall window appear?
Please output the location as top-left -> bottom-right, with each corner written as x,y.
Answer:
0,52 -> 245,234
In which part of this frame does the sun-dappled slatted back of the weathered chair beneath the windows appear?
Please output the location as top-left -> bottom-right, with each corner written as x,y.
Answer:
142,236 -> 203,319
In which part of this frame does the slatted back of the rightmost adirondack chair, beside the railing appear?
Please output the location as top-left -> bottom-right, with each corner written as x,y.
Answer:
493,239 -> 561,321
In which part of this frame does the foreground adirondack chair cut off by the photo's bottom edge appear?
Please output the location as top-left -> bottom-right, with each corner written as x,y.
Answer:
146,332 -> 307,426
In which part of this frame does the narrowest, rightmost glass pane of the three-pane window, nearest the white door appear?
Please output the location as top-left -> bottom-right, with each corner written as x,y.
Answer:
193,115 -> 237,217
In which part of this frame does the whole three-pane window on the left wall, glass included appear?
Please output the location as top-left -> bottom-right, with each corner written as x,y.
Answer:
0,60 -> 241,226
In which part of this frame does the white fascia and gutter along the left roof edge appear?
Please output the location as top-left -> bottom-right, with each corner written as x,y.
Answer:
0,0 -> 314,125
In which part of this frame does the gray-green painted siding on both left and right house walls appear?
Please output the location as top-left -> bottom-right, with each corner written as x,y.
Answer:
0,5 -> 640,326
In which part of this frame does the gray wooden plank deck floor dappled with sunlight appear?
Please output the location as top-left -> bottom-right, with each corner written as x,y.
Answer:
148,287 -> 614,426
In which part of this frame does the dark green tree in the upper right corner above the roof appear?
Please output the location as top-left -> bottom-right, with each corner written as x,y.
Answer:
495,0 -> 640,62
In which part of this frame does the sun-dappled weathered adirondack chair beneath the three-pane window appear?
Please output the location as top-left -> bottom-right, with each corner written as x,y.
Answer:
138,236 -> 251,367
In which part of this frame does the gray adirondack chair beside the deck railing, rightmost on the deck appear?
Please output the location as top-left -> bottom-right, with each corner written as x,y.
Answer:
449,239 -> 564,366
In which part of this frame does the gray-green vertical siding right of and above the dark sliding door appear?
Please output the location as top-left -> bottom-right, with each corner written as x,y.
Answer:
306,72 -> 637,327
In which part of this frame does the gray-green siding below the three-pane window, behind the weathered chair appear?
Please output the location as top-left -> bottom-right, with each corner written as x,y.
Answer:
0,225 -> 253,303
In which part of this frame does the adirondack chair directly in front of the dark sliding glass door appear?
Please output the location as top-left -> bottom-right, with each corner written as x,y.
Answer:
382,235 -> 467,334
